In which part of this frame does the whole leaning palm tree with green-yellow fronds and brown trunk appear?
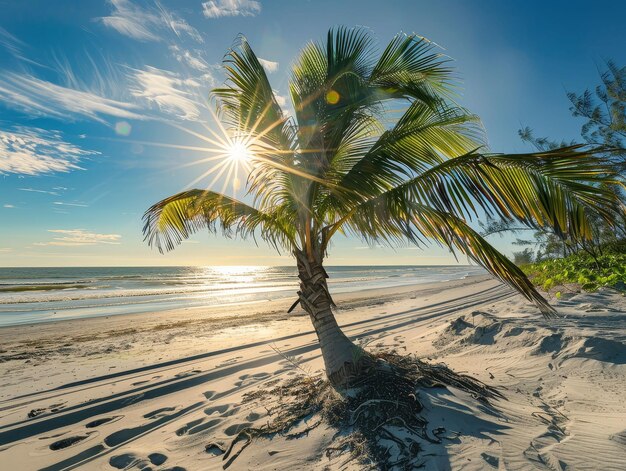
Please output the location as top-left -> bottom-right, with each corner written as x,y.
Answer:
144,27 -> 617,386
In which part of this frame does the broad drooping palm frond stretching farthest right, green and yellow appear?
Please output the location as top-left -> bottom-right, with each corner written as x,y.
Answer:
378,146 -> 623,239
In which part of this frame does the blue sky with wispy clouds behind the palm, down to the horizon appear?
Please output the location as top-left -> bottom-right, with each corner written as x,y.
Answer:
0,0 -> 626,266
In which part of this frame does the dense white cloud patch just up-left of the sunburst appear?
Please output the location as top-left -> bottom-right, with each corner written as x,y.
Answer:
130,67 -> 200,119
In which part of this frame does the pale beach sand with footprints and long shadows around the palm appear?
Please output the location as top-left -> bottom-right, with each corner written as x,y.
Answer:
0,277 -> 626,471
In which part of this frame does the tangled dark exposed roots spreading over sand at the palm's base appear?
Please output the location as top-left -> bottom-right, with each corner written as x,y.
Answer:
223,351 -> 503,470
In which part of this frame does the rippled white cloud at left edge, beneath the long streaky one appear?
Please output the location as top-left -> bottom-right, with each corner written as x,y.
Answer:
0,127 -> 98,176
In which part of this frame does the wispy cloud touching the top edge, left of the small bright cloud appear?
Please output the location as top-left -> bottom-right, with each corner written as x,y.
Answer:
100,0 -> 204,43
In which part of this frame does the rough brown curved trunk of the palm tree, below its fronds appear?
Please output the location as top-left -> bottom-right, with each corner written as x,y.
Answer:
295,251 -> 371,388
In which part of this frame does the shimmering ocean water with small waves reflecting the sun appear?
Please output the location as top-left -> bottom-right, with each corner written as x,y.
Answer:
0,265 -> 485,326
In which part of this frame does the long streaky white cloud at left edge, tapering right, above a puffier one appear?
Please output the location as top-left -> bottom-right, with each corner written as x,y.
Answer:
0,72 -> 144,122
